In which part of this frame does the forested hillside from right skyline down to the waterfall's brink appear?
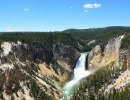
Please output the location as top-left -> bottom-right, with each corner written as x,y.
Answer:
64,26 -> 130,51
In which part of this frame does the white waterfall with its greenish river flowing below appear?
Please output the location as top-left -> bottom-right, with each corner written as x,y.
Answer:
61,53 -> 91,100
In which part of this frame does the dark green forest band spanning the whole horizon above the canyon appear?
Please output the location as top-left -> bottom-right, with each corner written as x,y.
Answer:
0,26 -> 130,52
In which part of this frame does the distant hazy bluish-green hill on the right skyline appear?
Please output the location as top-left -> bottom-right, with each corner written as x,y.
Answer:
64,26 -> 130,42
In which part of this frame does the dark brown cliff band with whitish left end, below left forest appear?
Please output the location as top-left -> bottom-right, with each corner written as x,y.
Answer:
0,42 -> 53,64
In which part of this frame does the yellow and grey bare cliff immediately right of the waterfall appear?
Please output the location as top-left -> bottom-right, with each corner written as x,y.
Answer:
89,36 -> 124,69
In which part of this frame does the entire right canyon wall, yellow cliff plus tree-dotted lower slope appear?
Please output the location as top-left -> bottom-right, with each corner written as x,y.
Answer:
71,35 -> 130,100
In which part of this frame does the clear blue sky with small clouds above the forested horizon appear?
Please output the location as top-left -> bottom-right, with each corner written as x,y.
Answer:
0,0 -> 130,31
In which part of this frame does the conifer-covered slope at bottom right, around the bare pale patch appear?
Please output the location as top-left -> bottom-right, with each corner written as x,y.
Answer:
71,61 -> 130,100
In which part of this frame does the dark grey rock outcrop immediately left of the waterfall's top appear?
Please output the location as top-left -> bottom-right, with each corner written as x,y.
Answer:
53,43 -> 80,70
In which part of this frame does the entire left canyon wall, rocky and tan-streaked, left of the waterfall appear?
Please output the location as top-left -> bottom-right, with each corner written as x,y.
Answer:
0,42 -> 79,100
